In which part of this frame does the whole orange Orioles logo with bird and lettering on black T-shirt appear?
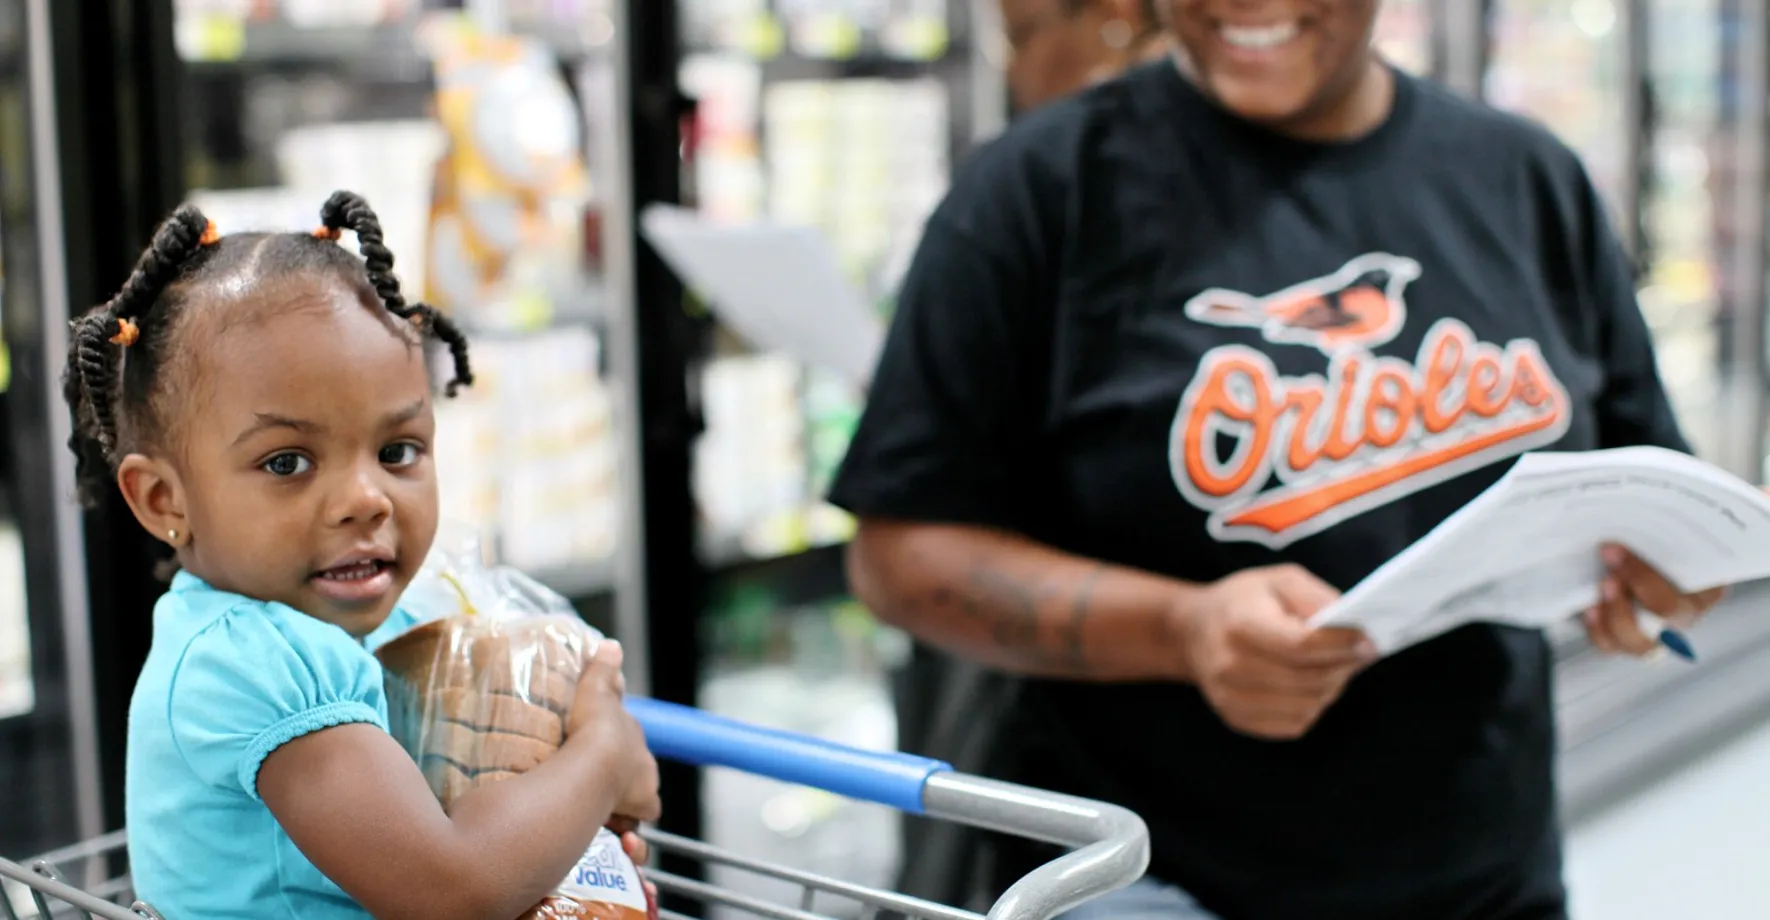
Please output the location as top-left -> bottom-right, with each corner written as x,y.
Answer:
1168,253 -> 1570,548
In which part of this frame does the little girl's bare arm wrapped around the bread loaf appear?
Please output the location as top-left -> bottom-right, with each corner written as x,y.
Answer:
258,644 -> 658,920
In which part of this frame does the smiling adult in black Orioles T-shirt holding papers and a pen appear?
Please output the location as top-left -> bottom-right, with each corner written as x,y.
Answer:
832,0 -> 1719,920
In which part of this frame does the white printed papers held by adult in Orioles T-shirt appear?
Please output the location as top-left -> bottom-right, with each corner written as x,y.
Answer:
1312,448 -> 1770,653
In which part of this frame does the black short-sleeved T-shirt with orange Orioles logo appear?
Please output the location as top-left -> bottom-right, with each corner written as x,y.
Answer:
832,62 -> 1685,920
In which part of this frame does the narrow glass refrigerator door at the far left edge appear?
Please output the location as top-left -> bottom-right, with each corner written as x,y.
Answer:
0,0 -> 103,863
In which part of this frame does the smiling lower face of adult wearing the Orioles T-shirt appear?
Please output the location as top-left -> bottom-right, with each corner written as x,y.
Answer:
1161,0 -> 1379,133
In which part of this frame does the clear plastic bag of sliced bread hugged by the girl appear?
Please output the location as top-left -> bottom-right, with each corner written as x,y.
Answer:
375,533 -> 657,920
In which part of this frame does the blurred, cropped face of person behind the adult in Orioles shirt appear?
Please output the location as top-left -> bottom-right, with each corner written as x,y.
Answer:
1002,0 -> 1165,110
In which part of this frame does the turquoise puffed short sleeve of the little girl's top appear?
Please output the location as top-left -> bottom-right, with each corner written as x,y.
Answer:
168,603 -> 388,800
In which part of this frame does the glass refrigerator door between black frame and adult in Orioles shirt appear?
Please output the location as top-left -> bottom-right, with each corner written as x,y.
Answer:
678,0 -> 993,897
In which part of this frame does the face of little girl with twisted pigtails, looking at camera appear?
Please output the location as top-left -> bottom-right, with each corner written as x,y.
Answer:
120,278 -> 437,635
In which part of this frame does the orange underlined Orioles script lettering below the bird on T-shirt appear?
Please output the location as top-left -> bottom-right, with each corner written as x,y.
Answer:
1170,318 -> 1568,536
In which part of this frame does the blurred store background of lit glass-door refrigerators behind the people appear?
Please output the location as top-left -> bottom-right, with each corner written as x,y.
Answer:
0,0 -> 1770,920
